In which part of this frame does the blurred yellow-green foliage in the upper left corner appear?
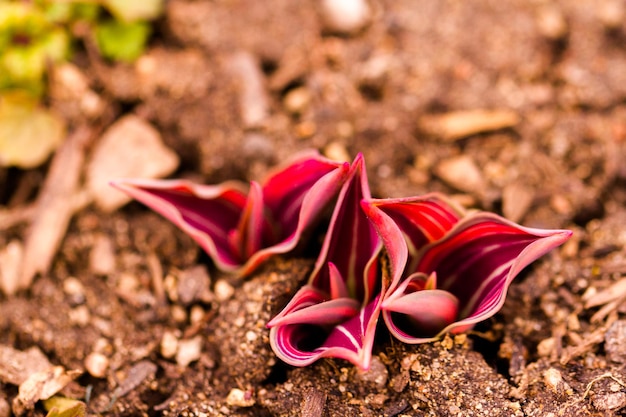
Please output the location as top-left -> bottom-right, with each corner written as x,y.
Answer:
0,0 -> 164,167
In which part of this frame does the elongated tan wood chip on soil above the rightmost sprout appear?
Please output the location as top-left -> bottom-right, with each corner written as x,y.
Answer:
418,110 -> 520,142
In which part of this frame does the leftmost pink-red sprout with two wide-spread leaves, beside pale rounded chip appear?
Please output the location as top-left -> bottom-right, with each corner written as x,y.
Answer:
112,152 -> 350,275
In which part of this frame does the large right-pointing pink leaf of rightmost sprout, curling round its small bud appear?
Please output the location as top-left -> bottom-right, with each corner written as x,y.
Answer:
383,212 -> 572,343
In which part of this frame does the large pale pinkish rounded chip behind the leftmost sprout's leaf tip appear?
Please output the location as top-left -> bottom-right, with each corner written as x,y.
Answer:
87,115 -> 179,212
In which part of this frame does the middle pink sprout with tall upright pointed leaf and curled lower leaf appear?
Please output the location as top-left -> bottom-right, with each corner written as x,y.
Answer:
269,155 -> 382,368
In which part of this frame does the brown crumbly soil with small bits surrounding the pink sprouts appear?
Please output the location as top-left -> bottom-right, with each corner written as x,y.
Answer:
0,0 -> 626,417
